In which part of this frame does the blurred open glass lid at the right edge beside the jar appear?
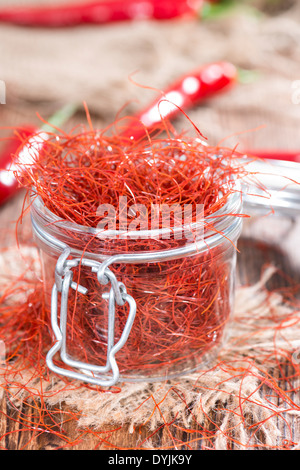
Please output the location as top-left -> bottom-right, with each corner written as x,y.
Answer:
239,159 -> 300,286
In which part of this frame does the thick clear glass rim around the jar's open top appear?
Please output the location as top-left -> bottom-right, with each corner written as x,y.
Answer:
31,186 -> 242,263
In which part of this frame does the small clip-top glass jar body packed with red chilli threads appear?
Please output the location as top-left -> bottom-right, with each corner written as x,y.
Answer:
32,191 -> 242,386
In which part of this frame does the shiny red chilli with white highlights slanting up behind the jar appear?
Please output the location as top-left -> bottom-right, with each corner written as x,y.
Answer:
122,62 -> 238,139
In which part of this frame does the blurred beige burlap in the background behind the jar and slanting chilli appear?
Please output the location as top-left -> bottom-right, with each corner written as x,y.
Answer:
0,0 -> 300,149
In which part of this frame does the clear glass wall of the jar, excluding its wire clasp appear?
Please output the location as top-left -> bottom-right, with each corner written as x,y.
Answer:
32,193 -> 241,380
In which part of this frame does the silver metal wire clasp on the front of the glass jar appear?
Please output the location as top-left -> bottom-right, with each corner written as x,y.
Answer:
46,247 -> 136,387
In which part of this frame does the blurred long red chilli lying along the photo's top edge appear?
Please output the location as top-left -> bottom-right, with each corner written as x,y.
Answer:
0,0 -> 203,27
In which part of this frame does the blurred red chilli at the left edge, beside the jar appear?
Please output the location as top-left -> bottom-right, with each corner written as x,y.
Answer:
0,127 -> 37,204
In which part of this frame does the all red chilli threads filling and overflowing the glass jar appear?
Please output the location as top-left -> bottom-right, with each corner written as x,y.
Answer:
15,121 -> 247,378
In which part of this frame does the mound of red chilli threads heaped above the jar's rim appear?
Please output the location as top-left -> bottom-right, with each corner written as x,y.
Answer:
17,131 -> 246,227
